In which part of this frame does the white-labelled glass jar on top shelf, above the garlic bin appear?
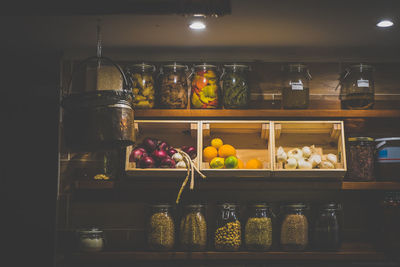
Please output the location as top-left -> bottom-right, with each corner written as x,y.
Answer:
282,64 -> 311,109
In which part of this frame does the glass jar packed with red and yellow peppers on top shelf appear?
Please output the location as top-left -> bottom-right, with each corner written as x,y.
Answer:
191,64 -> 220,109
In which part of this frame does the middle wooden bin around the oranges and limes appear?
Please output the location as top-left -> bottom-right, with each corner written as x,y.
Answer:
199,121 -> 272,177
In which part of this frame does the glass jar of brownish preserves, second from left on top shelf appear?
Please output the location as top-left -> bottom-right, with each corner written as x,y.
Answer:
159,63 -> 188,109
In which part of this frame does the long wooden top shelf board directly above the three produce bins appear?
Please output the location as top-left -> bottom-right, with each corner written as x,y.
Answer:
135,109 -> 400,119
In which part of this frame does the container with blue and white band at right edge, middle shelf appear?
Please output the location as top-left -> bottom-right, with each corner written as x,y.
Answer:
375,137 -> 400,181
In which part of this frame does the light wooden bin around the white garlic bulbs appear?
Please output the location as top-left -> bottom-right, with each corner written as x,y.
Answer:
272,121 -> 347,179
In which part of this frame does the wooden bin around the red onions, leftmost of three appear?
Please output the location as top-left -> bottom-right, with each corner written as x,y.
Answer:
125,120 -> 199,177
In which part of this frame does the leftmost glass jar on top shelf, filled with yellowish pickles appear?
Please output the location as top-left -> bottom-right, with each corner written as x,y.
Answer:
127,63 -> 156,109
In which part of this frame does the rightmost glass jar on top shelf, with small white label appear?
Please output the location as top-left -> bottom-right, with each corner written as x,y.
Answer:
340,64 -> 375,109
